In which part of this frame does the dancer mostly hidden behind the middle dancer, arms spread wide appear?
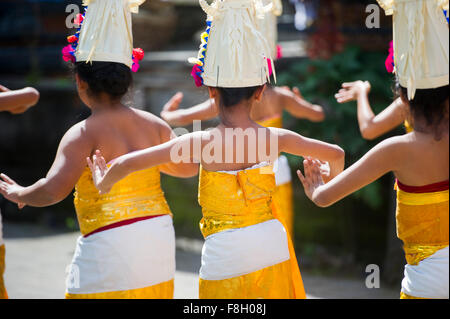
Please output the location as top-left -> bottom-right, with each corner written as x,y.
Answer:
161,0 -> 325,238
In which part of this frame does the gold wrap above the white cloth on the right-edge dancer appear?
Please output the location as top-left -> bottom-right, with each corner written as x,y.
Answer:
397,187 -> 449,265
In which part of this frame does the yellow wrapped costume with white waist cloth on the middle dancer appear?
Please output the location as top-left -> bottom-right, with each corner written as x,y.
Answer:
199,166 -> 306,299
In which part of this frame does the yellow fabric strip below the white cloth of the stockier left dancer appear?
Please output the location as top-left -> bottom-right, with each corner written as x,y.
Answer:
66,280 -> 174,299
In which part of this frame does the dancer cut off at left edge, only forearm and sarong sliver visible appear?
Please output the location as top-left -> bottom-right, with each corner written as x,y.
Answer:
0,85 -> 39,299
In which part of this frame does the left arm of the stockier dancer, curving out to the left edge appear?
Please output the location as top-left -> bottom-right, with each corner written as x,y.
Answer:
0,124 -> 93,207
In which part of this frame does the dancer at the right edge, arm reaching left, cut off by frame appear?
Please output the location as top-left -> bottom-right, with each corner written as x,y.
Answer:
298,0 -> 449,299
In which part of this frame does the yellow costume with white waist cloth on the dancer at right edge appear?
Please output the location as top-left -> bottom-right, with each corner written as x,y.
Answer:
396,182 -> 449,299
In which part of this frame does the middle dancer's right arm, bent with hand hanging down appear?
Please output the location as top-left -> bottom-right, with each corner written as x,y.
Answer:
271,129 -> 345,179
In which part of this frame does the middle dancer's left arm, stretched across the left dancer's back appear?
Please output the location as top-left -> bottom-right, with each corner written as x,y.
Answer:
87,132 -> 202,194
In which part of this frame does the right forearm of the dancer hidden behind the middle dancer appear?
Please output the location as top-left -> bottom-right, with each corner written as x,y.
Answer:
274,87 -> 325,122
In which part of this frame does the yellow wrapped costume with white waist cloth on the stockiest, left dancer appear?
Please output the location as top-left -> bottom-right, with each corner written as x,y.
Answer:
66,168 -> 175,299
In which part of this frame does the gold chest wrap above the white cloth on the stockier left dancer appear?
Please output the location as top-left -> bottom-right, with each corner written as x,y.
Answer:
74,167 -> 171,235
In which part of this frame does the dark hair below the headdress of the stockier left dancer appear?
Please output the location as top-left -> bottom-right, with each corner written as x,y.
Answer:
74,62 -> 133,99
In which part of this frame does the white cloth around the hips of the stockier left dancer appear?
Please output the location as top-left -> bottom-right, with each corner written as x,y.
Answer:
66,215 -> 175,294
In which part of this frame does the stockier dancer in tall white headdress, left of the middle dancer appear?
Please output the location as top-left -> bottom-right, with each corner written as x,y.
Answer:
0,0 -> 198,299
